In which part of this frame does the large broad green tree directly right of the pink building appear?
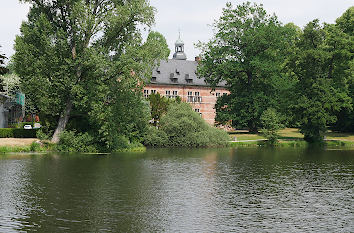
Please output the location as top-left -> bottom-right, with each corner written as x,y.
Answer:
198,2 -> 296,132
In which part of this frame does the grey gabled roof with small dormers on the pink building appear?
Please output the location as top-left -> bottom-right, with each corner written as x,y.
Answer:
150,59 -> 226,87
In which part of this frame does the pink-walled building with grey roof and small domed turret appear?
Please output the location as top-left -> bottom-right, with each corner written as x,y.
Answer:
144,35 -> 228,124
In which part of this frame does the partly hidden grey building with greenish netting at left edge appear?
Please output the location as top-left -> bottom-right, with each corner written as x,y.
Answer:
0,93 -> 24,128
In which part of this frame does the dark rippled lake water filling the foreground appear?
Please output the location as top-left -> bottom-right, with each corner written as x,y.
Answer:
0,149 -> 354,232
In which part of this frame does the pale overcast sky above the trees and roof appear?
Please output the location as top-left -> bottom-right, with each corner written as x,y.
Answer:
0,0 -> 354,60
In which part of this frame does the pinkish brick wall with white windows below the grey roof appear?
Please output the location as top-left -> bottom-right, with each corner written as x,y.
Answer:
144,84 -> 229,125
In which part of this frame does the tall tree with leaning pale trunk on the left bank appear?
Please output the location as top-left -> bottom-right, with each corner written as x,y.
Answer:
14,0 -> 169,146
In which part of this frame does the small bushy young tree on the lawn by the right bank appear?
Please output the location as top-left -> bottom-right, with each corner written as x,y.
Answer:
261,108 -> 284,146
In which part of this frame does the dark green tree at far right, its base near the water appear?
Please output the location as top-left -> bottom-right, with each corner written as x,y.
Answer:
289,20 -> 351,143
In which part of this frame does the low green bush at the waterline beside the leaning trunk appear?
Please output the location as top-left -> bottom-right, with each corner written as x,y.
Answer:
56,131 -> 97,152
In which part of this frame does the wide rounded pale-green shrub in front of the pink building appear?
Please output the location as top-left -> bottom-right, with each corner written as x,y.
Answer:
145,103 -> 229,147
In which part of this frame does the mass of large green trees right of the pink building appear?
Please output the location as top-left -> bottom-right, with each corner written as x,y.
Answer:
198,2 -> 354,142
